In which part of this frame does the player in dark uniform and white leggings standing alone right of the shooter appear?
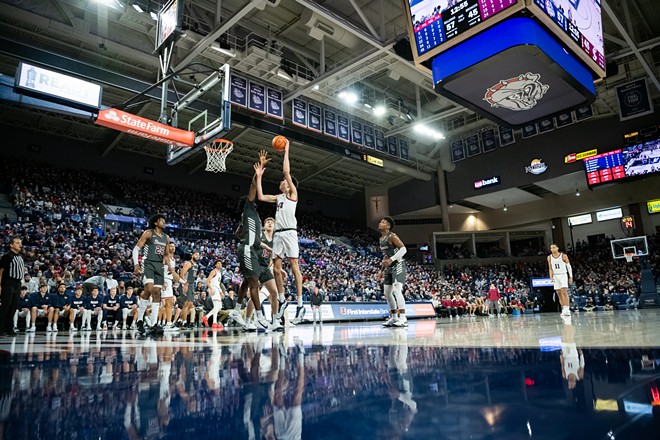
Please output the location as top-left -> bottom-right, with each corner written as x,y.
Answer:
378,217 -> 408,327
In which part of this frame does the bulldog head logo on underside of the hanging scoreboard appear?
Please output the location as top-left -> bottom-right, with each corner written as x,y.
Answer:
484,72 -> 550,112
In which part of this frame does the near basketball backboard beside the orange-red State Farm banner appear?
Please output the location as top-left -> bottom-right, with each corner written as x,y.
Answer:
167,64 -> 231,165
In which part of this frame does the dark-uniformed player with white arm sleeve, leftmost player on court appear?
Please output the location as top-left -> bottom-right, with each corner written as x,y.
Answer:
133,214 -> 170,334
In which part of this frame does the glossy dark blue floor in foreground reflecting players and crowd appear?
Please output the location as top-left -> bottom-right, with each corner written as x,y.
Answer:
0,322 -> 660,439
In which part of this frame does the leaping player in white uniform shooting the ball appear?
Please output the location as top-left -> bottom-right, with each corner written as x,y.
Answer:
257,148 -> 305,324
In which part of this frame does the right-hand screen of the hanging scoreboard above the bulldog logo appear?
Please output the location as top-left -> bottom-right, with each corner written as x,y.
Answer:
530,0 -> 605,76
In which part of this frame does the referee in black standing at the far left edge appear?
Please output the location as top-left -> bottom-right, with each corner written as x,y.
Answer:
0,237 -> 25,336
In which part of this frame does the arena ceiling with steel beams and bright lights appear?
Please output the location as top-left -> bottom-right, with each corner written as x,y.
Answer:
0,0 -> 660,206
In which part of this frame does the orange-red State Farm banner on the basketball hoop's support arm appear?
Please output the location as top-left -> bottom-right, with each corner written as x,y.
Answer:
94,108 -> 195,147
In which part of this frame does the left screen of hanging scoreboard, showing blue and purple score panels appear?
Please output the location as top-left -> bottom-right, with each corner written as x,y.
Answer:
404,0 -> 523,62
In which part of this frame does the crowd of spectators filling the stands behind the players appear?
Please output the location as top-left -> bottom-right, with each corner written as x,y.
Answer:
0,153 -> 659,328
